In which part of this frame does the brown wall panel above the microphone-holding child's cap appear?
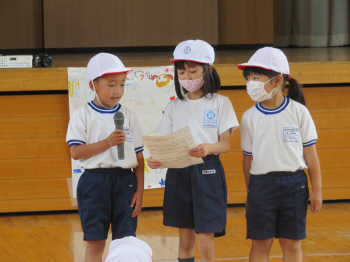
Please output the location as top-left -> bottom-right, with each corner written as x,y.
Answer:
43,0 -> 133,48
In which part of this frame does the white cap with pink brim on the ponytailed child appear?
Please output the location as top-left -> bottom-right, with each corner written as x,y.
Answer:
237,47 -> 289,75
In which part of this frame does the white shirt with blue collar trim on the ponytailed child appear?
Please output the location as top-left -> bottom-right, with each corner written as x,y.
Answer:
241,97 -> 317,175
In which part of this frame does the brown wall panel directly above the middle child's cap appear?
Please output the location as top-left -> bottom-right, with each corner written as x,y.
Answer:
132,0 -> 218,46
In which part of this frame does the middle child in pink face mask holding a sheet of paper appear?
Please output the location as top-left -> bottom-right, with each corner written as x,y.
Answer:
147,40 -> 239,262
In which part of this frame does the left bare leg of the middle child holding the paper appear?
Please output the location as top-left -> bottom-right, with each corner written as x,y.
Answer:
179,228 -> 196,259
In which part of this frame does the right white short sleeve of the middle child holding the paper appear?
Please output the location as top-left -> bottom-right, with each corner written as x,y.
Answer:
218,96 -> 239,135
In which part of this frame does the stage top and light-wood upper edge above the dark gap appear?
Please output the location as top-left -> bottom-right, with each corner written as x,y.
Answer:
0,47 -> 350,92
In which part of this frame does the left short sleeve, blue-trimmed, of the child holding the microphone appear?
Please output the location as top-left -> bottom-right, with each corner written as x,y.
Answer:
66,109 -> 87,147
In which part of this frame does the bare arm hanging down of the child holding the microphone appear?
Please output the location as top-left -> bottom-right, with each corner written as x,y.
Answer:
130,152 -> 145,217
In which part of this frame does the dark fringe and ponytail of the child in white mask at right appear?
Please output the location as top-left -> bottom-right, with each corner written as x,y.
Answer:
243,66 -> 305,105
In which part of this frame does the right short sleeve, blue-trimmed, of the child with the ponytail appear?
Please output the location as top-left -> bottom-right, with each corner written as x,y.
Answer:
300,107 -> 317,147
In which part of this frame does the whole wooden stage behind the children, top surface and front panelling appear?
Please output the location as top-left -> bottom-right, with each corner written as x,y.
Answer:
0,47 -> 350,213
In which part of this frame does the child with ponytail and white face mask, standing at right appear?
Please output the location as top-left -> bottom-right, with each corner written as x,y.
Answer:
238,47 -> 322,262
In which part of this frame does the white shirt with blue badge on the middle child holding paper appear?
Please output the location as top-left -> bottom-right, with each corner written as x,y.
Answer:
157,94 -> 239,145
